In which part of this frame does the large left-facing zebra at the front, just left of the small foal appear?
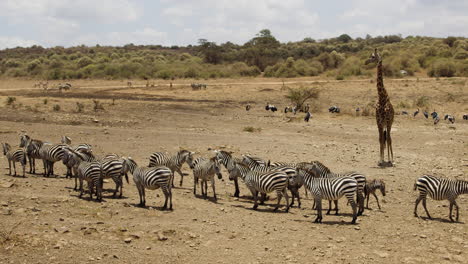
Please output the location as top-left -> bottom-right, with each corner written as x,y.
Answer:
296,168 -> 358,224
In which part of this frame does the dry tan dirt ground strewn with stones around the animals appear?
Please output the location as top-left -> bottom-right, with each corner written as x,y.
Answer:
0,79 -> 468,263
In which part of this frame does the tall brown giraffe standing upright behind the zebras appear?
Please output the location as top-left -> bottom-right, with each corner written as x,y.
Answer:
366,49 -> 395,166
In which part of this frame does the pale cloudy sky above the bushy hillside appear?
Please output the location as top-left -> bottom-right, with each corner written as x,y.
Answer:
0,0 -> 468,49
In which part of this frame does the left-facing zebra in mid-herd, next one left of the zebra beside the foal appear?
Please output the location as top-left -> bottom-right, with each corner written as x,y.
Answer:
228,162 -> 289,212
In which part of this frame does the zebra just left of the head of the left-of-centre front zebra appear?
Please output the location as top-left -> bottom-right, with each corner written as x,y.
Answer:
101,158 -> 129,198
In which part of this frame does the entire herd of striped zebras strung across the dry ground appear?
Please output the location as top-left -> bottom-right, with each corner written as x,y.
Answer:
2,135 -> 468,223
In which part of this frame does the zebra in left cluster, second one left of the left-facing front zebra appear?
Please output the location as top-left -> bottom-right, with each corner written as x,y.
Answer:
77,161 -> 102,201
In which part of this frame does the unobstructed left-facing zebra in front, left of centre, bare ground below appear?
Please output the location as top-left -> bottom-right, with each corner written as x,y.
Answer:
124,157 -> 174,210
